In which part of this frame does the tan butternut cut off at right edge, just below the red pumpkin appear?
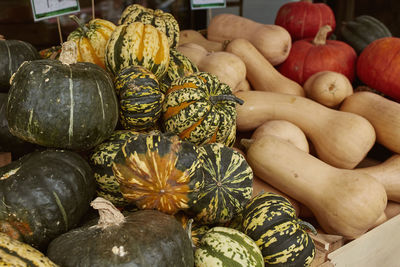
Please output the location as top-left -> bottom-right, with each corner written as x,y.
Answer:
340,91 -> 400,153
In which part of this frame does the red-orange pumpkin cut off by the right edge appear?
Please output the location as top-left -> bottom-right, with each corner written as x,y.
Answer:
356,37 -> 400,101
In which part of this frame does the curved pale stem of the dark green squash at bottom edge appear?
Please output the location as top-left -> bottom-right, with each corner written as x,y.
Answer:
90,197 -> 125,229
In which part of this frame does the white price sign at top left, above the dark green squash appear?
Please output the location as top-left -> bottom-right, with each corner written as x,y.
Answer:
31,0 -> 80,21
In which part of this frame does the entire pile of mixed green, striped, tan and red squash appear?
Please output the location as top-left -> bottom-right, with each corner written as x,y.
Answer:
0,0 -> 400,266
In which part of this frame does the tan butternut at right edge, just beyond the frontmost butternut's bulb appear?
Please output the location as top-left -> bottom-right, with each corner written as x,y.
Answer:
354,154 -> 400,202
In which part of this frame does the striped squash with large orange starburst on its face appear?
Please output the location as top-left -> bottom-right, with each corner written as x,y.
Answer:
112,132 -> 203,214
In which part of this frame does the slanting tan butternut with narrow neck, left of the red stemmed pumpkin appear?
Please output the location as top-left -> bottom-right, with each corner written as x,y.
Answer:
225,39 -> 305,96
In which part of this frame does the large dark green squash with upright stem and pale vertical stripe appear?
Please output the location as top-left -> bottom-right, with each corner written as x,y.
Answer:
7,41 -> 118,150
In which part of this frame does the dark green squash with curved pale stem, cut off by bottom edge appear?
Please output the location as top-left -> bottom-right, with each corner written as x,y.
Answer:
47,198 -> 194,267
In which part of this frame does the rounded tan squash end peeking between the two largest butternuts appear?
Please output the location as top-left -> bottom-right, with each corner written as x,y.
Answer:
251,120 -> 309,153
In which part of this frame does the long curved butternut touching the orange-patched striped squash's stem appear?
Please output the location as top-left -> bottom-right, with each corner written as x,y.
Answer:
235,91 -> 375,169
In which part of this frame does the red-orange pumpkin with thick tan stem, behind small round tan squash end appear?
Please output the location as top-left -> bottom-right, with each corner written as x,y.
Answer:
278,25 -> 357,85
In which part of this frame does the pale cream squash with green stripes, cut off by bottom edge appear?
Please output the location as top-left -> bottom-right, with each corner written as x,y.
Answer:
194,226 -> 264,267
